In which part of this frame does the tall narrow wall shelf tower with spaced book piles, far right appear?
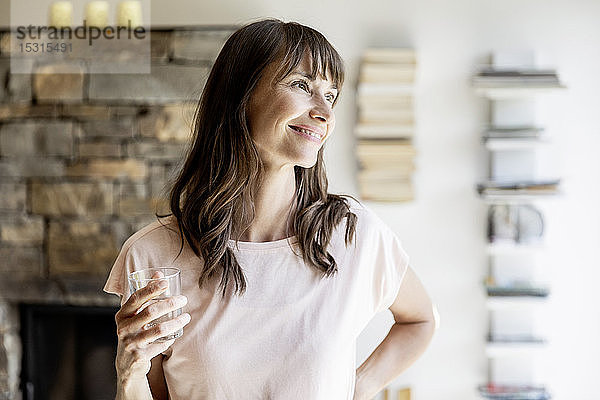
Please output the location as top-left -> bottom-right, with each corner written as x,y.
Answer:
472,52 -> 564,400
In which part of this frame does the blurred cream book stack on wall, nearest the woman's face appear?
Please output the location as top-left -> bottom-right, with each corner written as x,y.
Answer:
355,48 -> 416,202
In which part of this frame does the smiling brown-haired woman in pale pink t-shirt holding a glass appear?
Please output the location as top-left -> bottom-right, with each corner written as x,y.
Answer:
105,19 -> 434,400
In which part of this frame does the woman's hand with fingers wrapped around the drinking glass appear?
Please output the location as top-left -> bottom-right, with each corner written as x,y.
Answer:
115,281 -> 191,384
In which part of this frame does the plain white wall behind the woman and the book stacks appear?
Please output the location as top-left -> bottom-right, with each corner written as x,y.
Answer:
0,0 -> 600,400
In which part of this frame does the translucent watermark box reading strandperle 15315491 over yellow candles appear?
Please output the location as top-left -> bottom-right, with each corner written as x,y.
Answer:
9,0 -> 151,74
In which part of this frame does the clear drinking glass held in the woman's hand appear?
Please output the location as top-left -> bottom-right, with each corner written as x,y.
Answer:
129,267 -> 183,342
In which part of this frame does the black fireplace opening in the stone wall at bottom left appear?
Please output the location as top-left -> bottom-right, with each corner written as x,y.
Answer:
19,304 -> 117,400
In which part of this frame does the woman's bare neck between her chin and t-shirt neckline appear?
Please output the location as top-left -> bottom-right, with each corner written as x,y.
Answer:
240,165 -> 296,242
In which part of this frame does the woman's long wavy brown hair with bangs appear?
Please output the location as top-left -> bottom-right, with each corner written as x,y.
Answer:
165,19 -> 357,296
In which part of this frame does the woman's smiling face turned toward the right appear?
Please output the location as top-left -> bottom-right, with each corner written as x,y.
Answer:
247,55 -> 338,168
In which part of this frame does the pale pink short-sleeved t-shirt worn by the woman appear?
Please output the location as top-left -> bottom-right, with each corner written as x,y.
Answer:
104,200 -> 408,400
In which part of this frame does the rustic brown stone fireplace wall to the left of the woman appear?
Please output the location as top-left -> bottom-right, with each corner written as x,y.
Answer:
0,26 -> 235,399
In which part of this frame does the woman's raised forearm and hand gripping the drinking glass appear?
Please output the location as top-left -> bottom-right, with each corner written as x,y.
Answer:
115,282 -> 190,400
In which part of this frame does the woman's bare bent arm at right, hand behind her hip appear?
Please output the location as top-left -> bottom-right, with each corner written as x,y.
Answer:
354,266 -> 438,400
